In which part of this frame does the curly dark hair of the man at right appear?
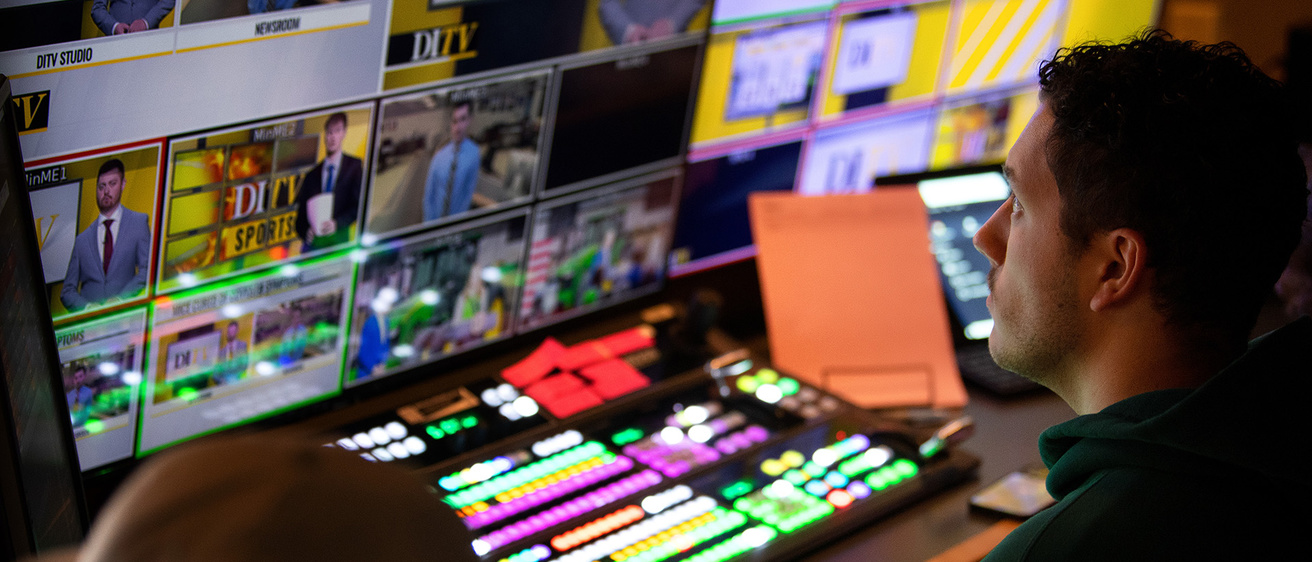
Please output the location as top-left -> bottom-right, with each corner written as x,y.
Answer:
1039,30 -> 1308,352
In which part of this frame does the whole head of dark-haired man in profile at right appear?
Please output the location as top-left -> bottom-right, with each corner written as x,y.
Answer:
975,32 -> 1307,414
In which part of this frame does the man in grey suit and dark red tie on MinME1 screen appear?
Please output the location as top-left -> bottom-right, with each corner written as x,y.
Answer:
59,158 -> 151,313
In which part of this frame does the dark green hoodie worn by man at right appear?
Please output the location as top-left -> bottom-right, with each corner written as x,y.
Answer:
985,318 -> 1312,561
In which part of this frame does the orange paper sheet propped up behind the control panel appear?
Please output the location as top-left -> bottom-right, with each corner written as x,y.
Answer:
748,186 -> 966,408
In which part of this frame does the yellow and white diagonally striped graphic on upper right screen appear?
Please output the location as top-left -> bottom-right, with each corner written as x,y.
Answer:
946,0 -> 1065,93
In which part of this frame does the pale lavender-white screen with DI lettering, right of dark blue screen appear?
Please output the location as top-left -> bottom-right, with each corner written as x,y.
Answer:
798,110 -> 934,196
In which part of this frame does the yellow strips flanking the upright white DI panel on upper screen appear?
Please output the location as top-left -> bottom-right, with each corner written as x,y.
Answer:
820,1 -> 951,117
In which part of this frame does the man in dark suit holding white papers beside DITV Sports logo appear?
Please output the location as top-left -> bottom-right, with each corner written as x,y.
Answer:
297,112 -> 365,252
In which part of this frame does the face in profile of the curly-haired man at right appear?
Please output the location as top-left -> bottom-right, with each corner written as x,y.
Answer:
975,105 -> 1088,387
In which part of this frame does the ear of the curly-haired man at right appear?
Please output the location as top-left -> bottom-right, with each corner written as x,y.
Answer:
1089,228 -> 1148,311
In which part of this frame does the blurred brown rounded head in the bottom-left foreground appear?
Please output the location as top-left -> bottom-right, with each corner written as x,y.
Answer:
63,436 -> 478,562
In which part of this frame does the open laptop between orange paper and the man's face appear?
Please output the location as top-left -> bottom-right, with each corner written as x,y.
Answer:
876,165 -> 1040,395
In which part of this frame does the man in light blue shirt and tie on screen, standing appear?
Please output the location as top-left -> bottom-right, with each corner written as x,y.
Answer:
424,97 -> 479,222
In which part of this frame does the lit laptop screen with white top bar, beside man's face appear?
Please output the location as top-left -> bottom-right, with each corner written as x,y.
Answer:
917,169 -> 1010,340
